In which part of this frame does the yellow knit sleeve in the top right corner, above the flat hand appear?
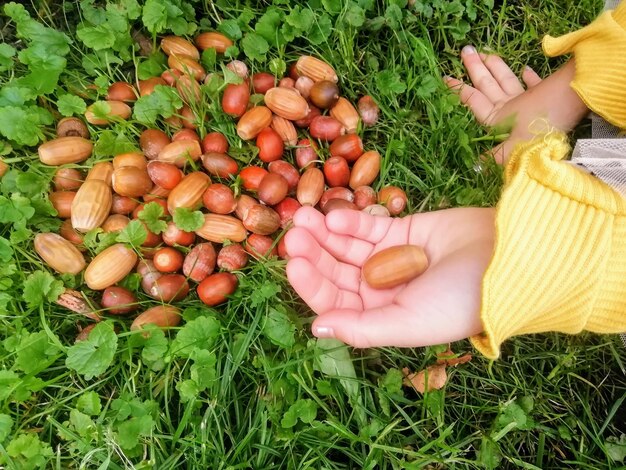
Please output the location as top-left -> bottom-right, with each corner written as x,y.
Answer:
543,1 -> 626,129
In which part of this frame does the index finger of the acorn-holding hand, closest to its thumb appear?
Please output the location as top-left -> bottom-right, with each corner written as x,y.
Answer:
287,258 -> 363,314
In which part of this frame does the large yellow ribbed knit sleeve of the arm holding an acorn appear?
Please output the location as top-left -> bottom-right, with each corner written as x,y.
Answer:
471,134 -> 626,359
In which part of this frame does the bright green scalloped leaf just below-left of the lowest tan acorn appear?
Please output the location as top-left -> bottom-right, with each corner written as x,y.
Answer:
65,321 -> 117,380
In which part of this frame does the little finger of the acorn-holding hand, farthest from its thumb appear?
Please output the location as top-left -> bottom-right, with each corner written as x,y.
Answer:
326,210 -> 394,243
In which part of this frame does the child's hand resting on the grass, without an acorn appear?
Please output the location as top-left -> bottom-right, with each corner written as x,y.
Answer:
446,46 -> 588,163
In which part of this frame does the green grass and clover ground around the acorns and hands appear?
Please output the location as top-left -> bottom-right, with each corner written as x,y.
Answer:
0,0 -> 626,470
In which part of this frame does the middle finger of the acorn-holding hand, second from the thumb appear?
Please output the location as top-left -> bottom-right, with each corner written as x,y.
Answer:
285,227 -> 361,292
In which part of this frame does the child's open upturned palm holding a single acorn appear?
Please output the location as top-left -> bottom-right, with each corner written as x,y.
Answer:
286,207 -> 495,347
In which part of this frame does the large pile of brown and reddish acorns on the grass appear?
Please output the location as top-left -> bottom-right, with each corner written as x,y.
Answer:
35,32 -> 407,336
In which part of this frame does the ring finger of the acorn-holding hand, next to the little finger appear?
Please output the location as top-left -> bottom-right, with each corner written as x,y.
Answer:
293,207 -> 374,267
